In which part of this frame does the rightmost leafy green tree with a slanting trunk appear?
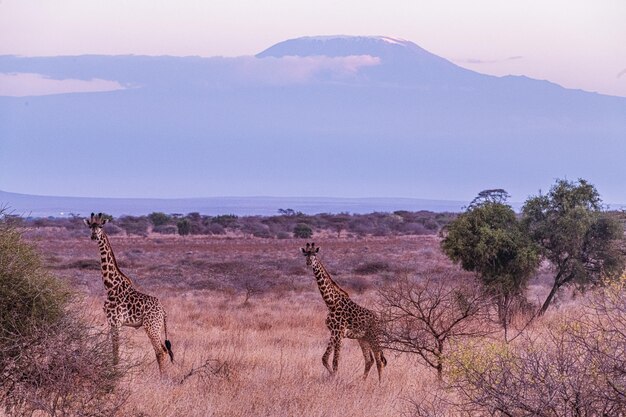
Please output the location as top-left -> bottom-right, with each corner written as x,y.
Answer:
522,179 -> 624,314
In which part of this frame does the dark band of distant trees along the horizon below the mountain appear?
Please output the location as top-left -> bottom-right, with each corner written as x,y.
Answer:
14,209 -> 457,239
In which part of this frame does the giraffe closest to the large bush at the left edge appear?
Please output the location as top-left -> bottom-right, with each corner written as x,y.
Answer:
83,213 -> 174,373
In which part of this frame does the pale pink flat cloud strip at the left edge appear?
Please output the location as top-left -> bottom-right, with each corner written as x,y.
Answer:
0,72 -> 125,97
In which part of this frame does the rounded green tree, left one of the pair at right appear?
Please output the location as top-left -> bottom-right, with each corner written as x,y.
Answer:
441,189 -> 540,332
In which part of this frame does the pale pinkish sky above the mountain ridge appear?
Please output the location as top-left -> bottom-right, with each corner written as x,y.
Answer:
0,0 -> 626,97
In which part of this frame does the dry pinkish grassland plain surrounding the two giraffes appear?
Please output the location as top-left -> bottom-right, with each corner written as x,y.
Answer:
11,227 -> 621,417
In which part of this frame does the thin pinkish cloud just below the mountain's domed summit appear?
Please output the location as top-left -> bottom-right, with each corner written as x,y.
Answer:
236,55 -> 380,84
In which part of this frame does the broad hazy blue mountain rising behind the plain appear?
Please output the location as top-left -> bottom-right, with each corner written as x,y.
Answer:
0,36 -> 626,203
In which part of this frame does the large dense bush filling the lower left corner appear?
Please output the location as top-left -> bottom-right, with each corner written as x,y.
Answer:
0,212 -> 127,416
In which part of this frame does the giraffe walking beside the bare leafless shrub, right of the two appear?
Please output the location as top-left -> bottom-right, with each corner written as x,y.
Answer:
302,243 -> 387,383
